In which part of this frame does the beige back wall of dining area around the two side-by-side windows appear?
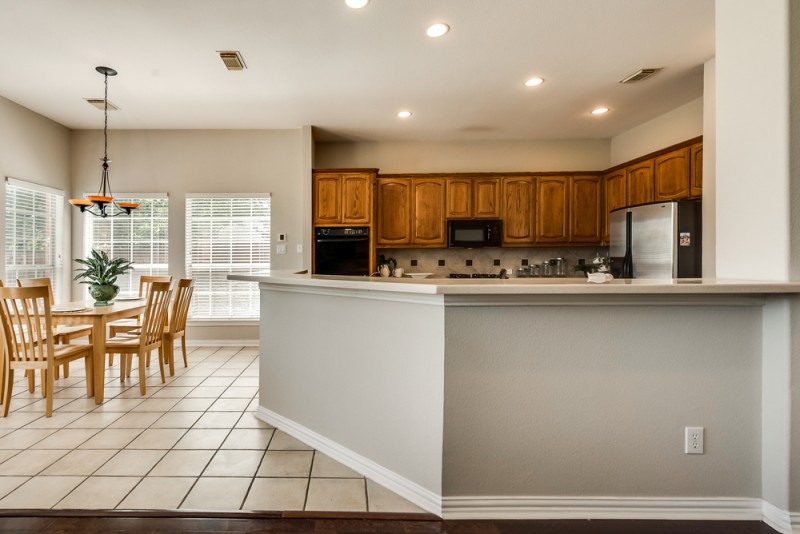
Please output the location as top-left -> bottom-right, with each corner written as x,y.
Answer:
71,129 -> 311,341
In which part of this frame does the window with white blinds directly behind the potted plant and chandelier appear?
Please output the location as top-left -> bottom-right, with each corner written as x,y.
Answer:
83,193 -> 169,295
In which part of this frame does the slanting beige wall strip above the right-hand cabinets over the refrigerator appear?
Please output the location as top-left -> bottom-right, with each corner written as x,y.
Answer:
609,97 -> 703,166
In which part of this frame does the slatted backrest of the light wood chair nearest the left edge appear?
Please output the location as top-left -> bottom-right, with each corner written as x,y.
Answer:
0,286 -> 53,367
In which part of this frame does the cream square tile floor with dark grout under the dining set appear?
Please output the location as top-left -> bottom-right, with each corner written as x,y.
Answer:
0,347 -> 424,512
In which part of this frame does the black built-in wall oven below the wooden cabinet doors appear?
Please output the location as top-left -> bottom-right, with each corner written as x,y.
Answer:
314,226 -> 370,276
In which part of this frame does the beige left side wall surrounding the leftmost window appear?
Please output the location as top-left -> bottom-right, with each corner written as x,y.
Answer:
0,97 -> 70,298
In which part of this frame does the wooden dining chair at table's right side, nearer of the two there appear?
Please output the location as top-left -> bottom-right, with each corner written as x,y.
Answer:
106,282 -> 172,395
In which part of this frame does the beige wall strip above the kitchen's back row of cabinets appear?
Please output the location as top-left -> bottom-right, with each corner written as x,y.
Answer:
314,139 -> 610,173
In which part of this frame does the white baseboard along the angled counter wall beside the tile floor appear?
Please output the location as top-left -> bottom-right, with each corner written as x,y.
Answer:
256,406 -> 442,516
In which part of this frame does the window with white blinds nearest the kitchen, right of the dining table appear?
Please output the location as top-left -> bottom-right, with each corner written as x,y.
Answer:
186,194 -> 270,319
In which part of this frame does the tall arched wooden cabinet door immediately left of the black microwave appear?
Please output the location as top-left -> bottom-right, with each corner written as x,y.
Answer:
411,178 -> 447,246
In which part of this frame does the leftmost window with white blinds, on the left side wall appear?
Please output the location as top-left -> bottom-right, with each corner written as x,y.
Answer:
5,178 -> 68,300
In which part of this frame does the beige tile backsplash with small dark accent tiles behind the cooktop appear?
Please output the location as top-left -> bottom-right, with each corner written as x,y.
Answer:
378,247 -> 608,277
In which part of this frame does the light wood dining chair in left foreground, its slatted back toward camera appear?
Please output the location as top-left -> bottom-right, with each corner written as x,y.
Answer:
0,287 -> 94,417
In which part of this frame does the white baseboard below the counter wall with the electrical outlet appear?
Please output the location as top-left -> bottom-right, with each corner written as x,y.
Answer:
442,496 -> 762,521
